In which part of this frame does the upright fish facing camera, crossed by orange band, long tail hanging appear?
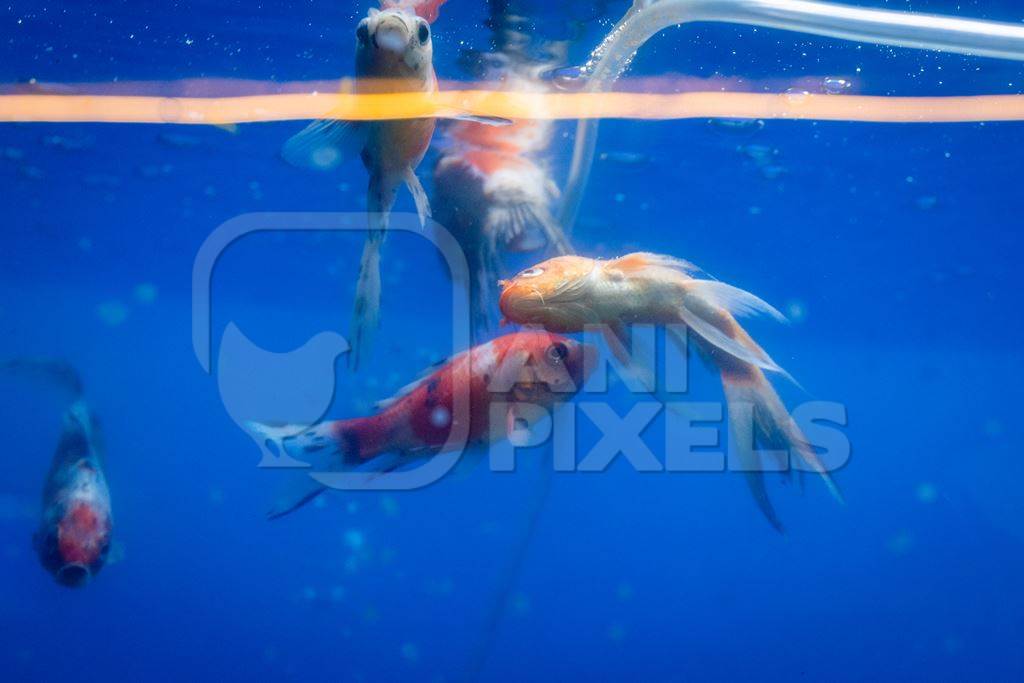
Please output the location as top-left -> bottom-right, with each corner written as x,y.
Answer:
282,0 -> 504,369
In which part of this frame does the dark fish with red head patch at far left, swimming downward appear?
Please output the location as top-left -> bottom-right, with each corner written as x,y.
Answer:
2,358 -> 114,588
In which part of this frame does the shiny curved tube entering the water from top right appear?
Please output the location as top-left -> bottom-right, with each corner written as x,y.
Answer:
559,0 -> 1024,231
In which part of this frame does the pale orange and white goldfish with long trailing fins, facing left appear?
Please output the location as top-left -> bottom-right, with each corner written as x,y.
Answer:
499,252 -> 842,531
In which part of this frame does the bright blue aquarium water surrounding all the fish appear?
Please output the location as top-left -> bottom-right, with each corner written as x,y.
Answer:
0,0 -> 1024,682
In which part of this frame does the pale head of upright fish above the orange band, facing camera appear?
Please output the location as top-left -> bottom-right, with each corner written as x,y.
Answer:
355,9 -> 434,87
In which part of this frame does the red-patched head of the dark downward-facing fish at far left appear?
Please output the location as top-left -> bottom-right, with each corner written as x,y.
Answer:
35,461 -> 113,588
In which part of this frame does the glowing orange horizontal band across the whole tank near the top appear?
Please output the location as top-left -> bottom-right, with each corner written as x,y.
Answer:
0,90 -> 1024,125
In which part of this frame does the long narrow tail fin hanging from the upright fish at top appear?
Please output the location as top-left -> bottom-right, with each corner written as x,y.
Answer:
348,174 -> 397,370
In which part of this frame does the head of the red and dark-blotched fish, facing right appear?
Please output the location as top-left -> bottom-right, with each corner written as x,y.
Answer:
498,330 -> 597,404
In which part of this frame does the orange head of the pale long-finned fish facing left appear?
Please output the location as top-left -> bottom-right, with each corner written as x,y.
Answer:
498,256 -> 601,332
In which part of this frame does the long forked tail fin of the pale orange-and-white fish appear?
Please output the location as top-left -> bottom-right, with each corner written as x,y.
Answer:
721,367 -> 843,531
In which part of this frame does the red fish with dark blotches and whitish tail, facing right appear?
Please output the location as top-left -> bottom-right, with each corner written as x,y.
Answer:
249,331 -> 596,519
